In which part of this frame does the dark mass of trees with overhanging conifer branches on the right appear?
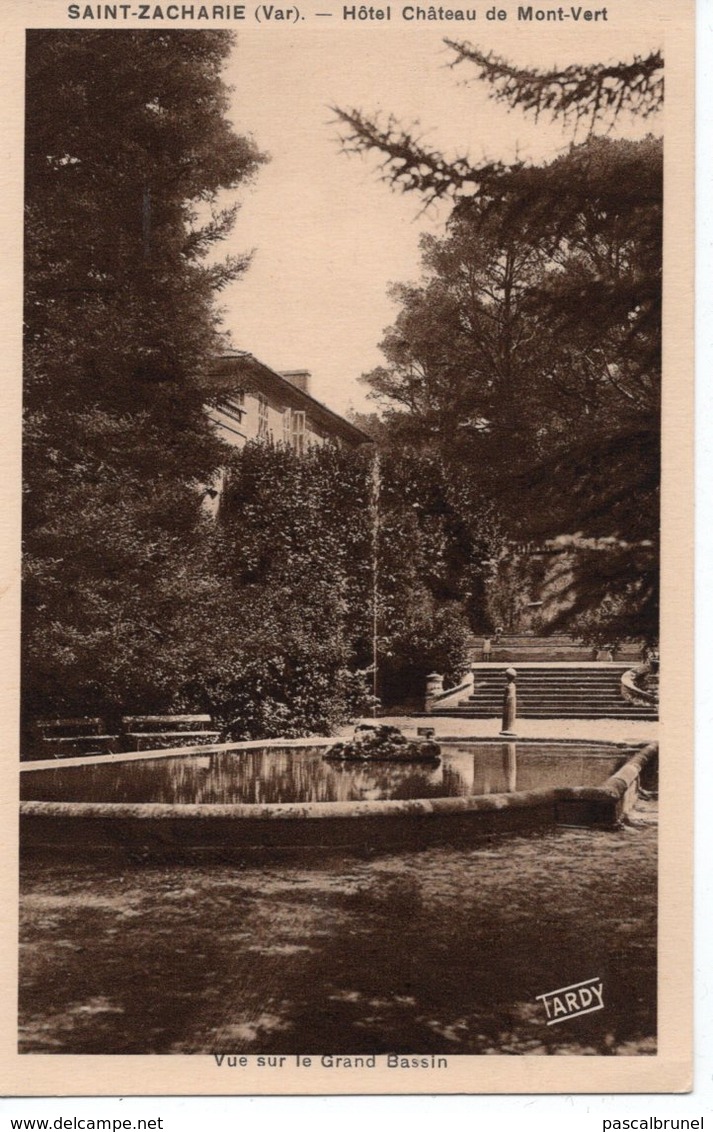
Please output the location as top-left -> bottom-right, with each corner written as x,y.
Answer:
338,43 -> 662,637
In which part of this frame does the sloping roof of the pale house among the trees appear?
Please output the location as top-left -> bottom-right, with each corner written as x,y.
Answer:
204,346 -> 373,445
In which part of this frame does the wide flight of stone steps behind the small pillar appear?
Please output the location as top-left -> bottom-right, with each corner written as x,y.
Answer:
433,662 -> 659,720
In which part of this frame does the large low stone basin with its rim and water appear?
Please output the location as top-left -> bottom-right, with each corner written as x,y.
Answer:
20,739 -> 658,854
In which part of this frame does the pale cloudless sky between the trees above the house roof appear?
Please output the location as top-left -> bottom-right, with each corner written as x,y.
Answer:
215,15 -> 664,412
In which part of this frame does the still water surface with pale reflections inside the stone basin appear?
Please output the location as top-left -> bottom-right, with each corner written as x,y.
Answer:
20,743 -> 625,804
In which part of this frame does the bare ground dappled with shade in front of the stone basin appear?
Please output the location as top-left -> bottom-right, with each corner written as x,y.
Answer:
20,805 -> 656,1054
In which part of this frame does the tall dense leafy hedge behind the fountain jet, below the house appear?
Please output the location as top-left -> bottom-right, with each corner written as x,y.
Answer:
205,444 -> 467,736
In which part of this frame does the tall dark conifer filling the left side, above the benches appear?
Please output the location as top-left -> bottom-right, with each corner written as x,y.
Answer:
23,31 -> 268,717
